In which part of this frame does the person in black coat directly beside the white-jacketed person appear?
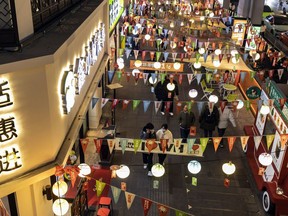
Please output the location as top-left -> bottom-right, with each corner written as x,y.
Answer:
199,105 -> 219,138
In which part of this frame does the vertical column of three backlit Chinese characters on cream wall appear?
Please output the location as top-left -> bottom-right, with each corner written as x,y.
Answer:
0,81 -> 22,174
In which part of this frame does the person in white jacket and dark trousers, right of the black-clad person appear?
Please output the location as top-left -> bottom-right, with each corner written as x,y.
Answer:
218,105 -> 236,148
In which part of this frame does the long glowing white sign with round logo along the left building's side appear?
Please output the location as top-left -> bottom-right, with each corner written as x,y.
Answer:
61,23 -> 105,114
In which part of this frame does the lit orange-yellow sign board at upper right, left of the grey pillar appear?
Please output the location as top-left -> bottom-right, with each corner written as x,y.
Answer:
231,18 -> 247,46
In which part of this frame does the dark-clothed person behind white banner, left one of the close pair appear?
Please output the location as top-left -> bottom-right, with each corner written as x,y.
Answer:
140,122 -> 156,176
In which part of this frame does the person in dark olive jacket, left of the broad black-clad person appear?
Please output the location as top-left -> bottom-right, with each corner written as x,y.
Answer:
178,105 -> 195,143
